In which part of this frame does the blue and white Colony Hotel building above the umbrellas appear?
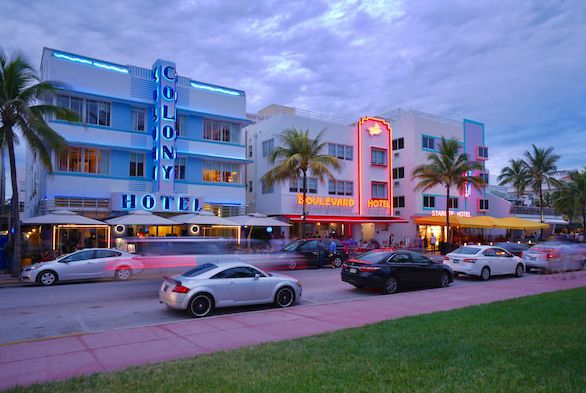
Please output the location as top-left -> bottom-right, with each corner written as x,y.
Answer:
25,48 -> 250,227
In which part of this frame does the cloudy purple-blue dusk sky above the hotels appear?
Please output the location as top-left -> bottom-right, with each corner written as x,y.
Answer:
0,0 -> 586,174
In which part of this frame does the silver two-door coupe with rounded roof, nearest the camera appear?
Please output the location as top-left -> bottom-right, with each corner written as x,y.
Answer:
159,262 -> 301,318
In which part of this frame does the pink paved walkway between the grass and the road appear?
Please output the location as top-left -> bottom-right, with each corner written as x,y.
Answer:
0,272 -> 586,389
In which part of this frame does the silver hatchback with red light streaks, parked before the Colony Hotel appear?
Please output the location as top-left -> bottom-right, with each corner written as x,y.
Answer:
19,248 -> 143,286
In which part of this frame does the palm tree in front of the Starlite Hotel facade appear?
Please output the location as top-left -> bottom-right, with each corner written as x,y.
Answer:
412,137 -> 485,243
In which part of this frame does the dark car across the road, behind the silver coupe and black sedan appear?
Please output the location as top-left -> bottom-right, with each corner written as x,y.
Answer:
271,238 -> 348,269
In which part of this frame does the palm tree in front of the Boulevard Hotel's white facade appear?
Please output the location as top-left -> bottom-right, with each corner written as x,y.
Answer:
262,128 -> 342,236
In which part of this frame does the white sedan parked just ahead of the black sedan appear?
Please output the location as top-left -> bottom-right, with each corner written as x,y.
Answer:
444,246 -> 525,280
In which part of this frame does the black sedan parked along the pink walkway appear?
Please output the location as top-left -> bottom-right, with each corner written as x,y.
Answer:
342,250 -> 454,293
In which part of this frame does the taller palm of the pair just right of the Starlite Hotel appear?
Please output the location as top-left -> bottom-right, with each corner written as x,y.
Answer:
524,145 -> 560,223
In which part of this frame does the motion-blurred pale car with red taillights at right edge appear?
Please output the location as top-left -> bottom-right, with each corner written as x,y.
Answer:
523,241 -> 586,273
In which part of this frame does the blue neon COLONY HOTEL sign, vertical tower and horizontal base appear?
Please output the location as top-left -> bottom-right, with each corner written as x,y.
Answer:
112,60 -> 203,212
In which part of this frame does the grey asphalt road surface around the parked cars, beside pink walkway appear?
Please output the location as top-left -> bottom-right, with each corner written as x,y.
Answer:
0,268 -> 509,344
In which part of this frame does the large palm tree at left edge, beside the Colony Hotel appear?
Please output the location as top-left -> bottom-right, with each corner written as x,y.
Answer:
0,50 -> 77,273
